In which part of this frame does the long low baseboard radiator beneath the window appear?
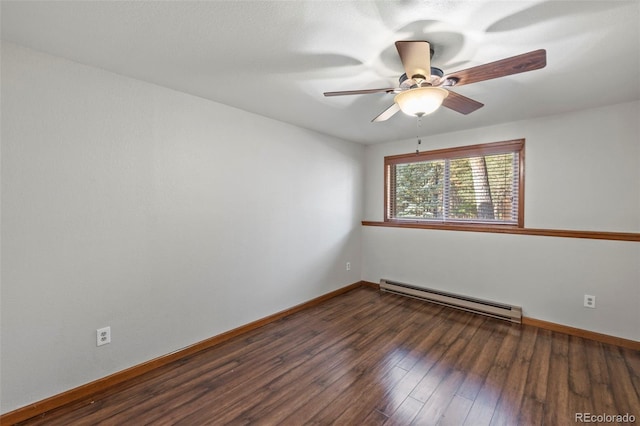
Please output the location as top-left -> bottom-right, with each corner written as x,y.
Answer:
380,279 -> 522,324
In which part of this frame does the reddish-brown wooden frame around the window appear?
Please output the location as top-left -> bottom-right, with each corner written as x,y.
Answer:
384,139 -> 525,229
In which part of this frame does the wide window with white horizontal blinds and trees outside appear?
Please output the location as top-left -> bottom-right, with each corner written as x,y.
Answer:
384,139 -> 524,227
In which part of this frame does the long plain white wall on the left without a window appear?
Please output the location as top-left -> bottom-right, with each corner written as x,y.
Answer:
0,44 -> 363,412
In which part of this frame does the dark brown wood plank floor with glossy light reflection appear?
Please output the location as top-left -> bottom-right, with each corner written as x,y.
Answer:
17,288 -> 640,426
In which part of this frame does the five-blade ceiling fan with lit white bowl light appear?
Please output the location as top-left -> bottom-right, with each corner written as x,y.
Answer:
324,40 -> 547,122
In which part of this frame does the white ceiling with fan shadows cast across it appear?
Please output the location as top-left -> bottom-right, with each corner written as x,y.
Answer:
1,0 -> 640,143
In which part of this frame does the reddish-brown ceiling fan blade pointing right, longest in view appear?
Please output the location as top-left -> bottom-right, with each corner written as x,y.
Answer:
442,49 -> 547,86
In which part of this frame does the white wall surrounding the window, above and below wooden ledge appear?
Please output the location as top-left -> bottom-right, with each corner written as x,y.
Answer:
362,102 -> 640,340
